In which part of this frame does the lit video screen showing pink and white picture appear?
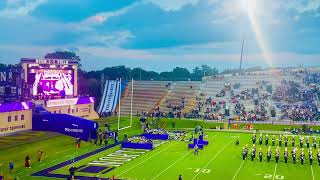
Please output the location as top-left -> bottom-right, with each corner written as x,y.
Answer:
28,69 -> 74,96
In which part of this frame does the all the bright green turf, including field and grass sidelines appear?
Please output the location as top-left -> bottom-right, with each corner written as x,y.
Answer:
0,116 -> 320,180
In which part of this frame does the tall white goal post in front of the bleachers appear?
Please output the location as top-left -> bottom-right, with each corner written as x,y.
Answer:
118,78 -> 134,131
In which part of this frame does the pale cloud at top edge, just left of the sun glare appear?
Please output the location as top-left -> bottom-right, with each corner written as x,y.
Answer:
145,0 -> 199,11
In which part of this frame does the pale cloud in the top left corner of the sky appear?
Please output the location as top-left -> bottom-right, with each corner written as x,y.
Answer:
0,0 -> 47,18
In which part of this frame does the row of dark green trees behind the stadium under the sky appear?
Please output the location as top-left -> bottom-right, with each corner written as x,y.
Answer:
0,51 -> 262,105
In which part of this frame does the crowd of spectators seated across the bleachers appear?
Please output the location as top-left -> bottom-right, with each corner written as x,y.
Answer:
102,72 -> 320,121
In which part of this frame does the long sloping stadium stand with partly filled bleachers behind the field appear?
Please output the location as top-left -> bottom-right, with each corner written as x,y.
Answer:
102,70 -> 320,121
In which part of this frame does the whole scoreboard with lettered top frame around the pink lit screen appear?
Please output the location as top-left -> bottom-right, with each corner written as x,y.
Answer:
21,58 -> 78,98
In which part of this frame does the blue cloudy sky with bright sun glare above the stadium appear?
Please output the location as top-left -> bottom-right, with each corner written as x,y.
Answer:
0,0 -> 320,71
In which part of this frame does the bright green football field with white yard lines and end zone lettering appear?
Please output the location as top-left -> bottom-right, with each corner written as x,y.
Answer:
48,132 -> 320,180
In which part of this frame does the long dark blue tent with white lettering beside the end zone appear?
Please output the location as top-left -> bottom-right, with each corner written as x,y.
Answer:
32,112 -> 98,141
